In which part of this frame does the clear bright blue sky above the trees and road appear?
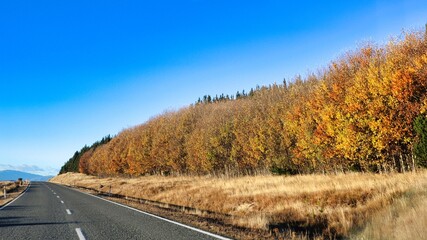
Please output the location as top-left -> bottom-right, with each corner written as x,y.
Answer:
0,0 -> 427,174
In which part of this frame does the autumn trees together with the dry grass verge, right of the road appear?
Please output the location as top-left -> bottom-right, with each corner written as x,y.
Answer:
56,27 -> 427,239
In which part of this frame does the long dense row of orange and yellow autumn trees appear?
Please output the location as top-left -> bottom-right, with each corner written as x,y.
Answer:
59,28 -> 427,176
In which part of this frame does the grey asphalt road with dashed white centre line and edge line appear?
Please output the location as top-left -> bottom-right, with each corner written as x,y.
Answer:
0,182 -> 231,240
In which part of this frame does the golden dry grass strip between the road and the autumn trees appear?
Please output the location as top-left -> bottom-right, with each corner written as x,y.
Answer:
51,171 -> 427,238
